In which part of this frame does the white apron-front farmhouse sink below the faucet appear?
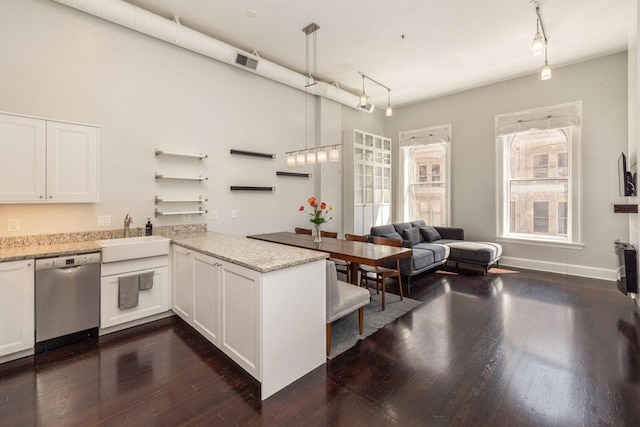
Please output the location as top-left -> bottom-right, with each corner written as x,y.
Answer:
98,236 -> 171,263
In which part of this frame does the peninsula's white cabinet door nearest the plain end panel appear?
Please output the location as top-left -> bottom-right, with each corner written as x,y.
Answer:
220,261 -> 260,380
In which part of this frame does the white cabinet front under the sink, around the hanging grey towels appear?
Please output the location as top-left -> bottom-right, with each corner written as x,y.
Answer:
100,255 -> 171,333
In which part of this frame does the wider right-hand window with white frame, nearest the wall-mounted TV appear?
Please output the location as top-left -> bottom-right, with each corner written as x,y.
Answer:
496,103 -> 581,244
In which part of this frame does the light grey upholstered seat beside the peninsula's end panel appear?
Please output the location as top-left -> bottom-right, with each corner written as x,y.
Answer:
327,260 -> 371,356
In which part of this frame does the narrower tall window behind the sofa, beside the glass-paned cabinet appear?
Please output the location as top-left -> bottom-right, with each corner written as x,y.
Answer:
400,125 -> 449,226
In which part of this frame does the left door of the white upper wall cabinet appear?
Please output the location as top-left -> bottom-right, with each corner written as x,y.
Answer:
0,114 -> 46,203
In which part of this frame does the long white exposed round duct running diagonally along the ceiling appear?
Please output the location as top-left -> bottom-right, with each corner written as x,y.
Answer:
53,0 -> 373,112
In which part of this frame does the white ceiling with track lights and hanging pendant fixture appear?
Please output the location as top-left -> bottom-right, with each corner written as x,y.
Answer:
122,0 -> 635,108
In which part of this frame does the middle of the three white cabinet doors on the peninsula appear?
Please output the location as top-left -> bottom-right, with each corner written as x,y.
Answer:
192,252 -> 220,347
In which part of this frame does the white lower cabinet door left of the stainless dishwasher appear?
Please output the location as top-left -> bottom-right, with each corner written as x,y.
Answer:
0,260 -> 35,356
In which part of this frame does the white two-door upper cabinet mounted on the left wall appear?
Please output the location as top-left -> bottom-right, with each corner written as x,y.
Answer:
0,114 -> 98,203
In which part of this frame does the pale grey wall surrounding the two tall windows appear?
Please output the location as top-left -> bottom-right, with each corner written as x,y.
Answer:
385,52 -> 628,277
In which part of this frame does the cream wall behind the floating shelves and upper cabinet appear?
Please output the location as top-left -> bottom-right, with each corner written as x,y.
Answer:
0,0 -> 375,236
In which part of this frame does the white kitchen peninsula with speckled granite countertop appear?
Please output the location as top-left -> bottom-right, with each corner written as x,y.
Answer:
168,232 -> 328,400
